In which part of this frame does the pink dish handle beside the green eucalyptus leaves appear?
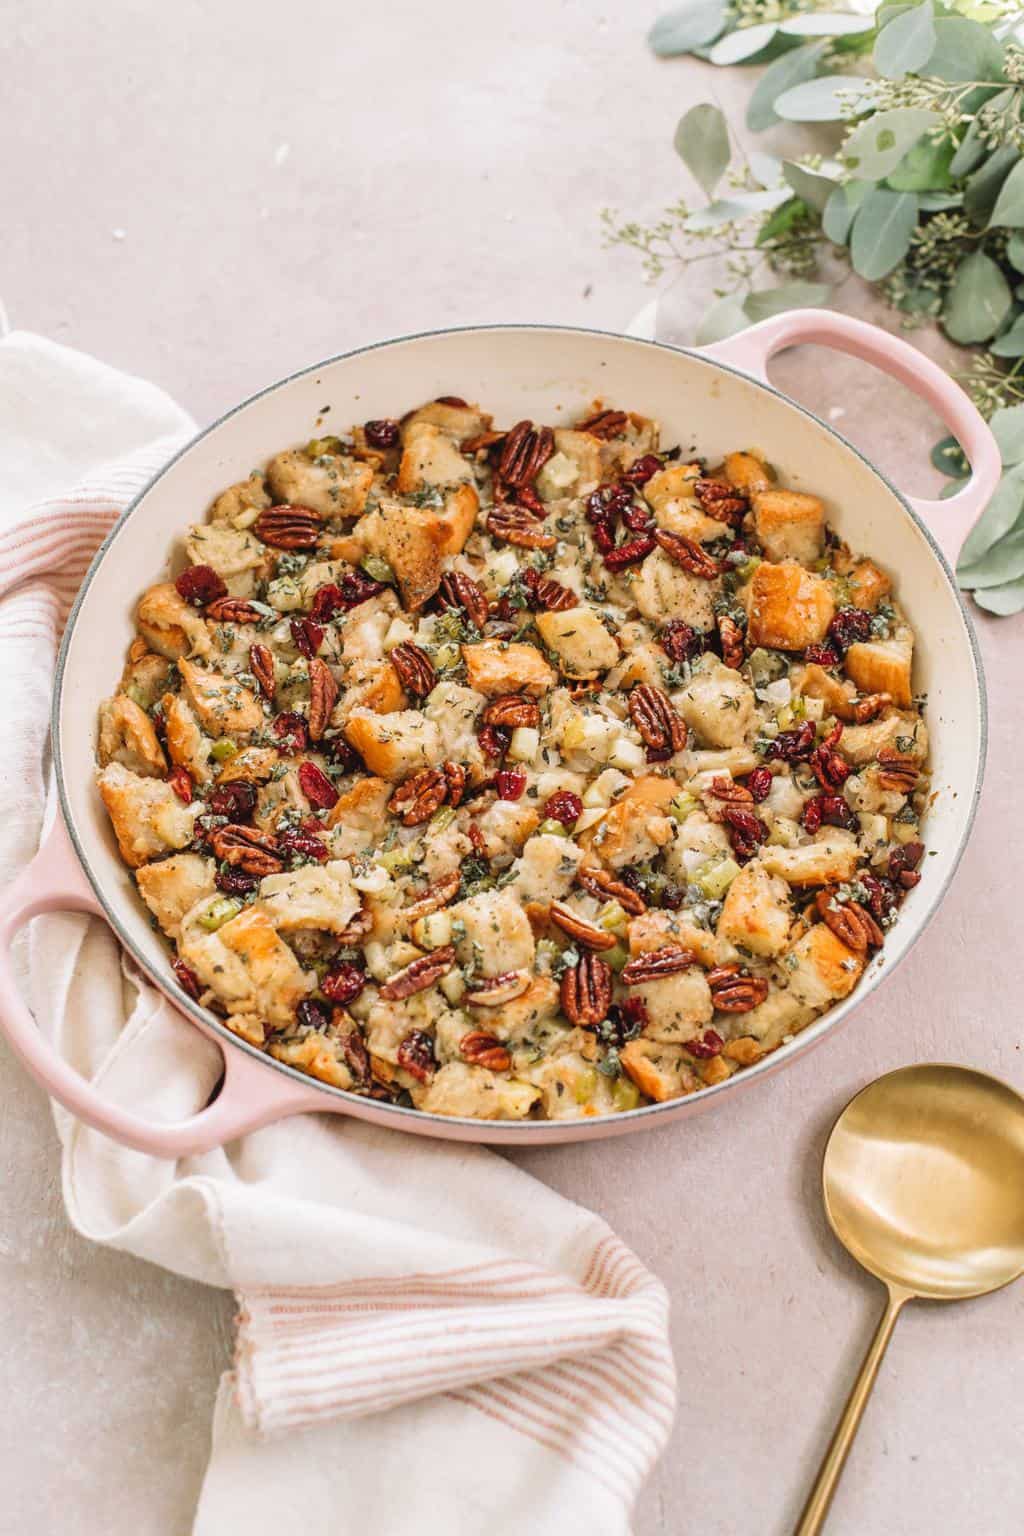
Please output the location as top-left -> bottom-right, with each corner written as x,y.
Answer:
695,309 -> 1003,567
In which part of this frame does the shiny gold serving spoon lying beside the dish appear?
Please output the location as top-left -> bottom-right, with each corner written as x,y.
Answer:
794,1064 -> 1024,1536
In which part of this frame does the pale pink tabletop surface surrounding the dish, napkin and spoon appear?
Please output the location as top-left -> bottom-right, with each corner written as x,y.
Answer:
0,0 -> 1024,1536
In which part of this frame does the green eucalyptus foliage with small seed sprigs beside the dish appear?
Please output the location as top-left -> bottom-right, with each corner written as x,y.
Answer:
605,0 -> 1024,614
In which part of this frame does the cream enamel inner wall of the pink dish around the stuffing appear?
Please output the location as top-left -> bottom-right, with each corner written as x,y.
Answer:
55,327 -> 984,1140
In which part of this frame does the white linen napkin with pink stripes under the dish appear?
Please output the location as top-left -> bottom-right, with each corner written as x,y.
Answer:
0,333 -> 676,1536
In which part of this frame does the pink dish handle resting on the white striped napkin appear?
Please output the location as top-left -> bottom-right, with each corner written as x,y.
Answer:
0,817 -> 330,1158
